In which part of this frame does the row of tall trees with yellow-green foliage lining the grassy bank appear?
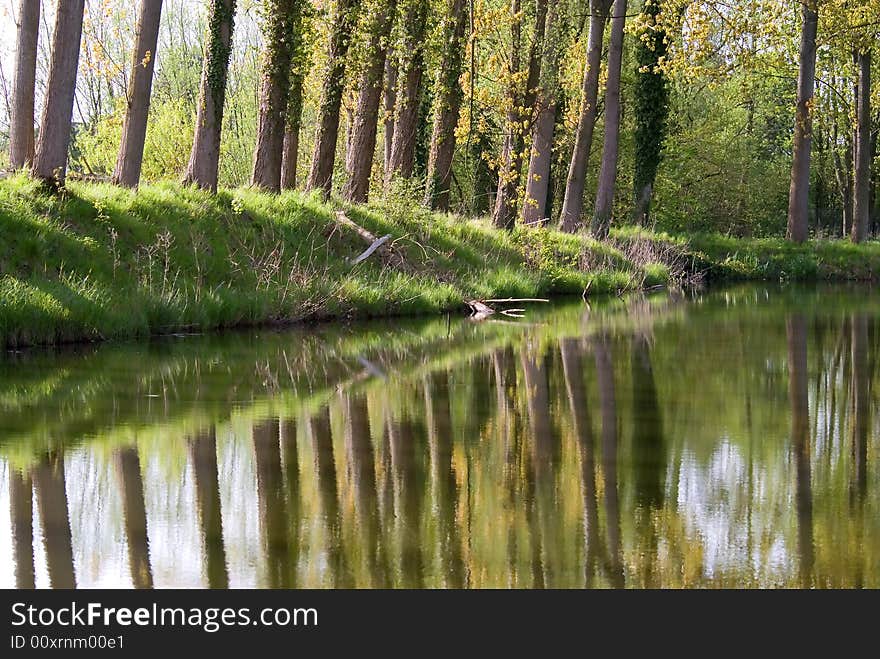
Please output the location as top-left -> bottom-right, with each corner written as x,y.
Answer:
1,0 -> 880,241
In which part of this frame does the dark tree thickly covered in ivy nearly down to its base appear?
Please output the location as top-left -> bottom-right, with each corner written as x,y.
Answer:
633,0 -> 669,225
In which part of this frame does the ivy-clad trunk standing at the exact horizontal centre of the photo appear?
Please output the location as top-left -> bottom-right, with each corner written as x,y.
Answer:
425,0 -> 468,211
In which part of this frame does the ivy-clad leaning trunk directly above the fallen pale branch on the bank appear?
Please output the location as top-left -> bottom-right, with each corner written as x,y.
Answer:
342,0 -> 397,204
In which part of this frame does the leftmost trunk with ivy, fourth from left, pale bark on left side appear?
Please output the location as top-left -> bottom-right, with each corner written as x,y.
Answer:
183,0 -> 235,192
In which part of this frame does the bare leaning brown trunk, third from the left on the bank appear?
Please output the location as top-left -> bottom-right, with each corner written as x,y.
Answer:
112,0 -> 162,188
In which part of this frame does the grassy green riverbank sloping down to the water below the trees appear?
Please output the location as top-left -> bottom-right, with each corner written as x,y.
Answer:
0,176 -> 880,348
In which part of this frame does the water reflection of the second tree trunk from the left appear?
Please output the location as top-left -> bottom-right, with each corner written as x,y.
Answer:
33,454 -> 76,588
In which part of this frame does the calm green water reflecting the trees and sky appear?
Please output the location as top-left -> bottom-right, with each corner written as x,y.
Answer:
0,286 -> 880,588
